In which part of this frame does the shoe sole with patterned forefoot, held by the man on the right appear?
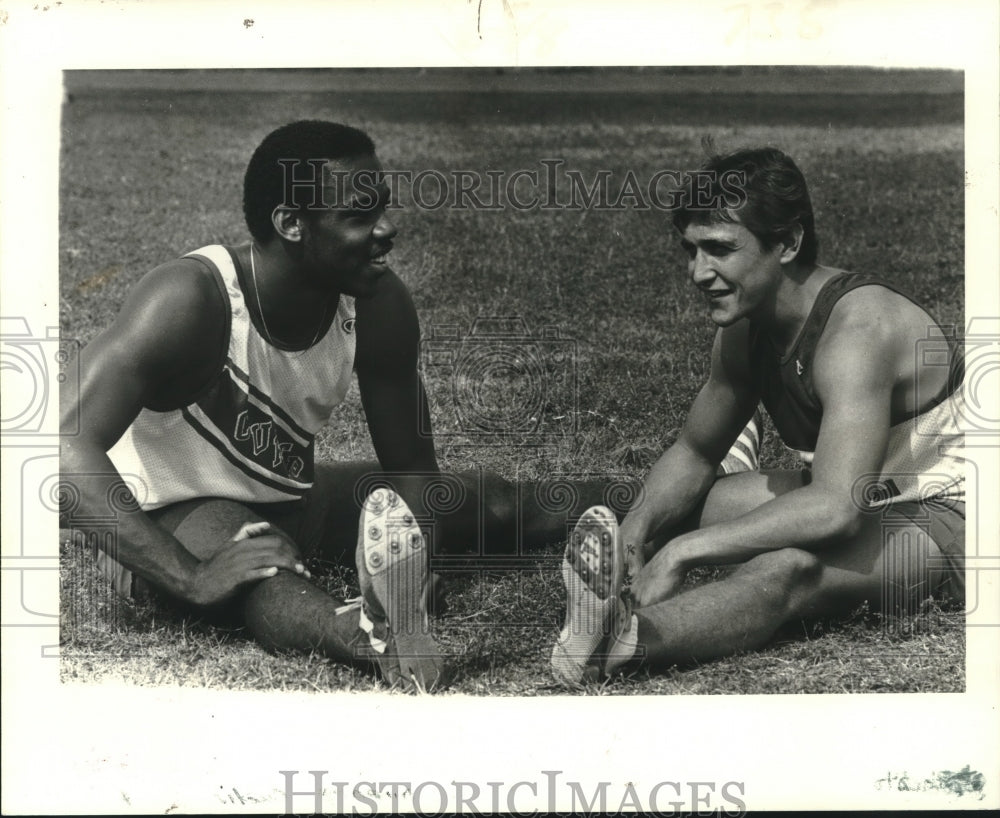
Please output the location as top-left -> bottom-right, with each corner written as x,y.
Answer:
552,506 -> 625,685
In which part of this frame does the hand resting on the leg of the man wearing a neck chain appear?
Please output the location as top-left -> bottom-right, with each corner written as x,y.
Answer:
188,522 -> 309,605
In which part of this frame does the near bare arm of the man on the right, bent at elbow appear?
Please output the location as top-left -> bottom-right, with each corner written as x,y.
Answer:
639,296 -> 912,597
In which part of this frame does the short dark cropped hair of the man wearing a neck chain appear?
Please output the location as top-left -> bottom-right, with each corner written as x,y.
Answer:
243,119 -> 375,241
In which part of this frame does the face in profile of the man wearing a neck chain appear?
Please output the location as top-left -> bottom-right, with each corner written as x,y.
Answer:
294,156 -> 396,298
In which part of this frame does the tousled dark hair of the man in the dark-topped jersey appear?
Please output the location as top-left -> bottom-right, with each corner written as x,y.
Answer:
673,147 -> 819,265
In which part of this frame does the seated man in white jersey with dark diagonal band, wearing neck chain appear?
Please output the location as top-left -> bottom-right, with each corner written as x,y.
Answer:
61,121 -> 601,688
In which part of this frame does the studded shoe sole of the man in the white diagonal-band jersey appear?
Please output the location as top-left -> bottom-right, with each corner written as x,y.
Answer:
358,489 -> 443,690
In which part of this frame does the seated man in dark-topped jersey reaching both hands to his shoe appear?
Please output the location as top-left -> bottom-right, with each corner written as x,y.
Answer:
552,148 -> 965,684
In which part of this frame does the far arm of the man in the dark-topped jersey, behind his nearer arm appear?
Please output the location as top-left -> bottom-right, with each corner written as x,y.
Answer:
621,322 -> 758,564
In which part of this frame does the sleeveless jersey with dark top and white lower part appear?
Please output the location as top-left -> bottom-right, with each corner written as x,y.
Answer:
749,273 -> 965,508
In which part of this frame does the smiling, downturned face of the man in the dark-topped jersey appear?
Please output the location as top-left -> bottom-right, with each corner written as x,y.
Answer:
681,222 -> 783,327
